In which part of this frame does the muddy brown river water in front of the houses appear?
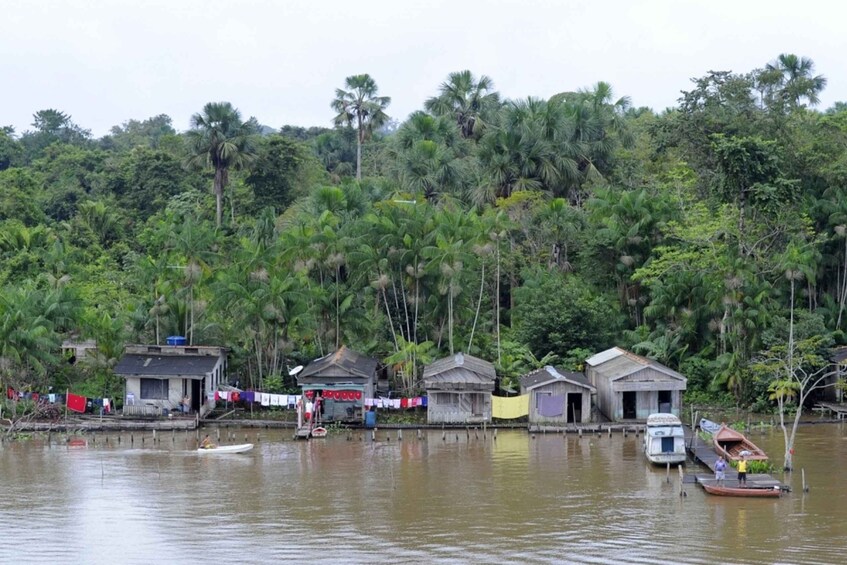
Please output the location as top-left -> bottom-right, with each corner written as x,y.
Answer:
0,424 -> 847,565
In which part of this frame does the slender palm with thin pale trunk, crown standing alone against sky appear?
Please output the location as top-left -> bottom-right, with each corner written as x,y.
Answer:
331,74 -> 391,180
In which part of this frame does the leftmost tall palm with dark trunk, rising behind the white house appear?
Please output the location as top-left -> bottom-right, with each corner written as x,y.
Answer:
185,102 -> 259,227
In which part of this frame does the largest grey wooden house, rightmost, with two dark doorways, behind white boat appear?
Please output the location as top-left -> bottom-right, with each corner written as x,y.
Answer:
585,347 -> 687,422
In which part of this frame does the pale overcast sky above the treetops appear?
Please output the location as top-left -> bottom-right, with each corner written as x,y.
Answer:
0,0 -> 847,137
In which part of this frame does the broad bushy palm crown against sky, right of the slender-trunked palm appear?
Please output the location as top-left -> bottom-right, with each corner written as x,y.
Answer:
424,71 -> 500,139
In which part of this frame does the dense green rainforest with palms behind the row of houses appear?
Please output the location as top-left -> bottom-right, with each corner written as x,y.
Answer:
0,54 -> 847,409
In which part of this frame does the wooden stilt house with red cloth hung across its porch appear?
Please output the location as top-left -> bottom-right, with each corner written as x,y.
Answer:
297,346 -> 379,422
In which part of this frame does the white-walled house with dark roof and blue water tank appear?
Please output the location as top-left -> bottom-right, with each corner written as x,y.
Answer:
115,345 -> 227,417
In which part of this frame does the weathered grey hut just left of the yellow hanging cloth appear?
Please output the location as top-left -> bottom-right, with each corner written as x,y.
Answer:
424,353 -> 497,424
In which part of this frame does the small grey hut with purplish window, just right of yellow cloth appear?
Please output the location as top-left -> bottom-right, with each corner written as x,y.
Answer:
521,365 -> 597,424
